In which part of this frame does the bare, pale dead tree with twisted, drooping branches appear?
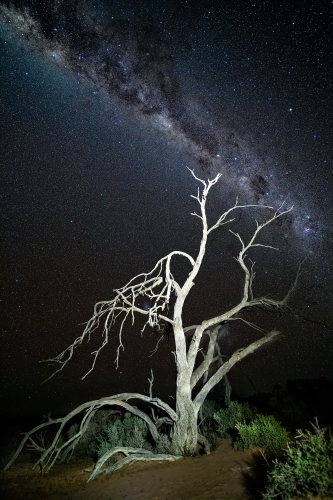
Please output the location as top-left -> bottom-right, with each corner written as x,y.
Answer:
2,171 -> 299,480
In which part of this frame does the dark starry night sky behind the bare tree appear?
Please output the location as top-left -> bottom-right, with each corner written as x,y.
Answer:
0,0 -> 333,415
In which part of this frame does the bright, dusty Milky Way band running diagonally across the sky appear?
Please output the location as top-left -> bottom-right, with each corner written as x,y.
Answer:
2,1 -> 331,254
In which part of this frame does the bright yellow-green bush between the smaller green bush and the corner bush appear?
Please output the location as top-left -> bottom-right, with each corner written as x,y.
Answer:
234,414 -> 288,455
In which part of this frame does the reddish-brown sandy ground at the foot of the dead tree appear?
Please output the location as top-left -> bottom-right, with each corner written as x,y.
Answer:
1,439 -> 267,500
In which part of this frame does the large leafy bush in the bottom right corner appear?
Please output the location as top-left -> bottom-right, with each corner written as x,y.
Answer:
263,419 -> 333,500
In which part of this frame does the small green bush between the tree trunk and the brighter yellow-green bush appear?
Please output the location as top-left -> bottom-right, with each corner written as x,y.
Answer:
213,401 -> 258,438
